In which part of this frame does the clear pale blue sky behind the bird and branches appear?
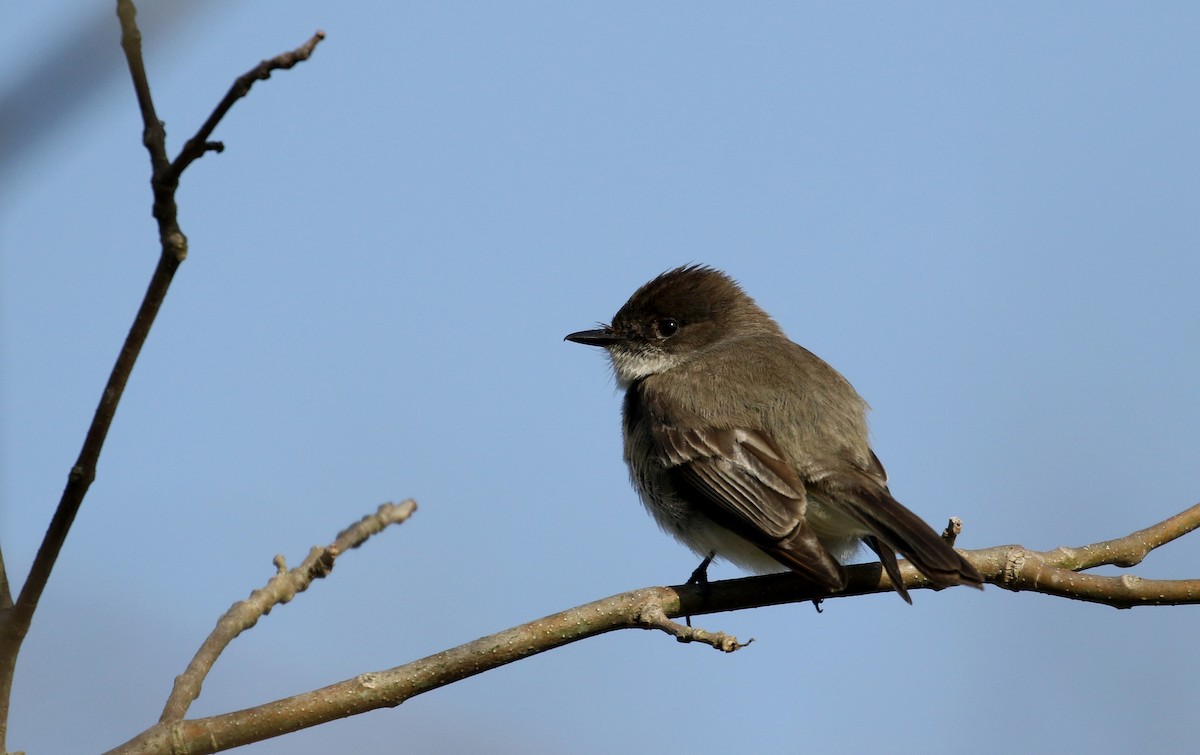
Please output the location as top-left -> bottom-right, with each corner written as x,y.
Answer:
0,0 -> 1200,754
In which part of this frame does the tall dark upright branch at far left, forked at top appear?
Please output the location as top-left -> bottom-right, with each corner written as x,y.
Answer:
0,0 -> 324,753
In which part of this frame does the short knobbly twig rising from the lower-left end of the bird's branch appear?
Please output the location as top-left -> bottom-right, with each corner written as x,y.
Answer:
158,501 -> 416,723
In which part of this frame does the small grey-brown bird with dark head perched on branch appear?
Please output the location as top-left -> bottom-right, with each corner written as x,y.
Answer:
566,265 -> 983,603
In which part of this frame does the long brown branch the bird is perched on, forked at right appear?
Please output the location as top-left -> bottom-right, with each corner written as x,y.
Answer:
110,504 -> 1200,755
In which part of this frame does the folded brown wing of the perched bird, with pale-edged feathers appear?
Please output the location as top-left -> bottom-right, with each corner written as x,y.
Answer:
653,426 -> 846,591
